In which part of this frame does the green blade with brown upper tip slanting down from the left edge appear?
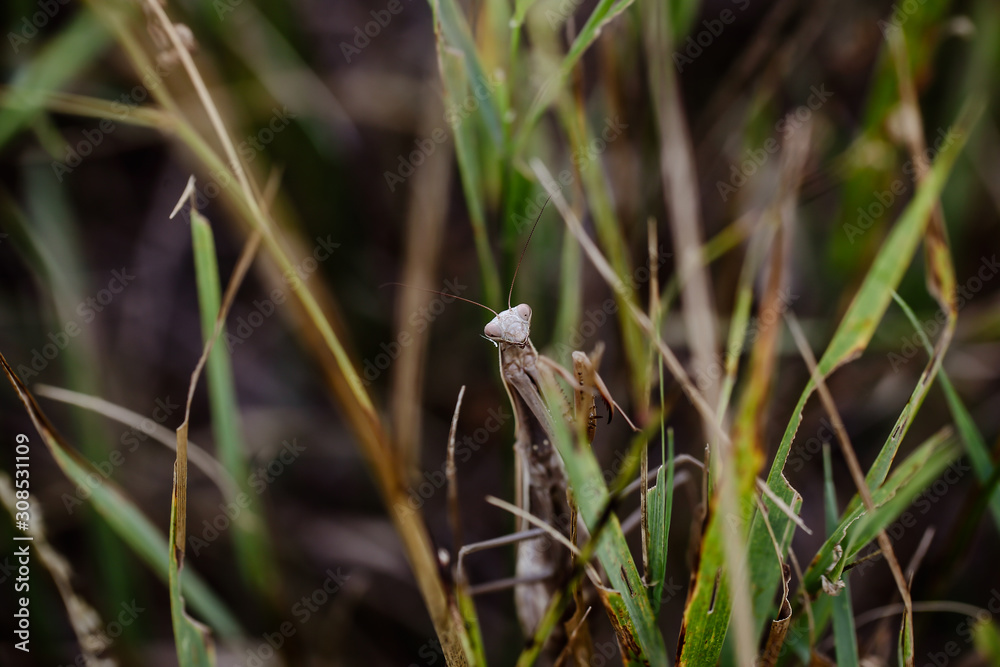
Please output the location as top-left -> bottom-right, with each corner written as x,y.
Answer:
0,353 -> 242,638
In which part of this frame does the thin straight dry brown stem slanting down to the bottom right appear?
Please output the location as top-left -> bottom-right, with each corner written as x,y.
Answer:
785,313 -> 913,667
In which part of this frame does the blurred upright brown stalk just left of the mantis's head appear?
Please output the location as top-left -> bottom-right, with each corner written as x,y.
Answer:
390,95 -> 451,479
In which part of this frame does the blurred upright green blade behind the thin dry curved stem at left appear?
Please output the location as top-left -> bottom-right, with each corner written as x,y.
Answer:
191,209 -> 276,592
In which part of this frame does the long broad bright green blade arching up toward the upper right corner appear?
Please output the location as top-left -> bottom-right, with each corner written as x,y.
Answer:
750,99 -> 981,630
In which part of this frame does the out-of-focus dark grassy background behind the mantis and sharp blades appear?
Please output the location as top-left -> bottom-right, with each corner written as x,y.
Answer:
0,0 -> 1000,667
